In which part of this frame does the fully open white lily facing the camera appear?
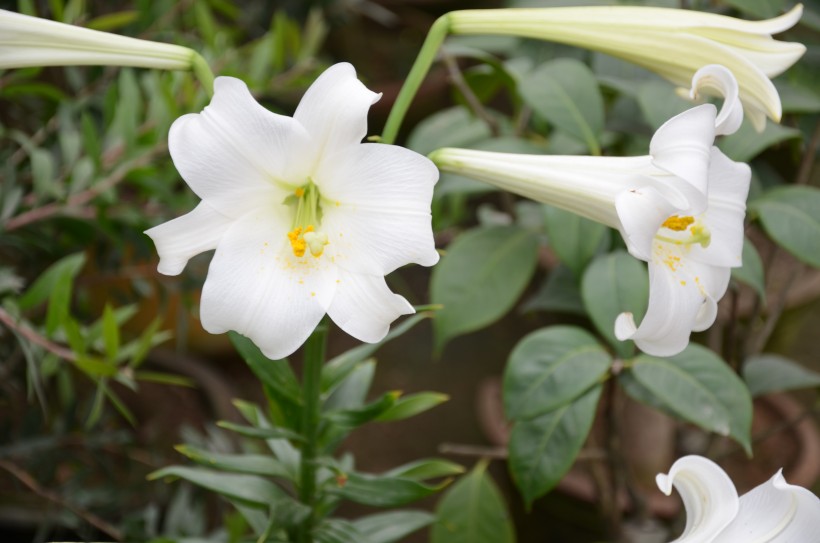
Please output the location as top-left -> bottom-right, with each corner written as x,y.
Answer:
146,64 -> 438,359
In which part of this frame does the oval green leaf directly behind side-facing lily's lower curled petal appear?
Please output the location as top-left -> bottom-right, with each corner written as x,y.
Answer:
581,251 -> 649,358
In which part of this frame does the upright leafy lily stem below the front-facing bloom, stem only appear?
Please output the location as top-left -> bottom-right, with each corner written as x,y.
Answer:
299,323 -> 327,543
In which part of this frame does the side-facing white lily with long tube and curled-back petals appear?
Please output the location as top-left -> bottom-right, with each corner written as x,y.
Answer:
430,66 -> 751,356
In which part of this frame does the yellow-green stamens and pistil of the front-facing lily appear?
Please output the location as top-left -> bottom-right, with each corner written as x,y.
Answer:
284,179 -> 328,258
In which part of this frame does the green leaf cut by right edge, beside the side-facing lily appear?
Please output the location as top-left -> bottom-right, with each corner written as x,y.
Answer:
749,185 -> 820,268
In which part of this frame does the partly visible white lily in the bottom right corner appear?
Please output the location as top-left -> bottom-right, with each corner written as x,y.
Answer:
655,456 -> 820,543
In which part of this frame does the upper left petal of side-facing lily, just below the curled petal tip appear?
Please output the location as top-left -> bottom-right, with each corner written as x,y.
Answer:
649,104 -> 717,214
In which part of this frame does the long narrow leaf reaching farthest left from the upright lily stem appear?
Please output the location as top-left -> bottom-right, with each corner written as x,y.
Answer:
148,466 -> 285,507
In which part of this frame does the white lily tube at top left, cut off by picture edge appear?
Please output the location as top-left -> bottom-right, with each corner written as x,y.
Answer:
0,10 -> 204,70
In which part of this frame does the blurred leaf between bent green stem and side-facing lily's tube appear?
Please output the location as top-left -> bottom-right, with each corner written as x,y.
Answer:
407,106 -> 491,155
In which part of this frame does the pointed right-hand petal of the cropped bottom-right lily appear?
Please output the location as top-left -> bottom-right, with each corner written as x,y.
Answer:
715,470 -> 820,543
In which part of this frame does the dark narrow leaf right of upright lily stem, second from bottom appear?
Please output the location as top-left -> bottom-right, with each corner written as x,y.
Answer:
327,472 -> 450,507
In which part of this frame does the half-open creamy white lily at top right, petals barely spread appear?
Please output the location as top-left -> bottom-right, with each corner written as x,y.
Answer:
446,4 -> 806,131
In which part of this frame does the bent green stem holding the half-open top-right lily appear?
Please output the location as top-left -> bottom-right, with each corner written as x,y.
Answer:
381,13 -> 450,144
